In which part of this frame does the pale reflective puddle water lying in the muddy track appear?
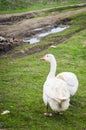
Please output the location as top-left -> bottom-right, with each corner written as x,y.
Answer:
23,26 -> 69,44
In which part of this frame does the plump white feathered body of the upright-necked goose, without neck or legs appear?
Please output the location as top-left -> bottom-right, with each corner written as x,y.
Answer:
43,78 -> 70,112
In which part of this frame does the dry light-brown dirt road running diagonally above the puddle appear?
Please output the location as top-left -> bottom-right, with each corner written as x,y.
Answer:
0,7 -> 86,38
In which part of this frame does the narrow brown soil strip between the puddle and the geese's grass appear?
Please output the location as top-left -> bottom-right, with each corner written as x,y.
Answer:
9,28 -> 84,58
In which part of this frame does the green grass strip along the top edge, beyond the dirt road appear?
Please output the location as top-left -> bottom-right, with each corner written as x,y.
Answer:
0,0 -> 85,14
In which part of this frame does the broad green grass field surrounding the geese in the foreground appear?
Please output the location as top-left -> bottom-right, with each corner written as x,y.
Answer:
0,12 -> 86,130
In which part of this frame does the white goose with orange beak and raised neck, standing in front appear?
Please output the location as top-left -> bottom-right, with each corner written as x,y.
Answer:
41,54 -> 70,116
